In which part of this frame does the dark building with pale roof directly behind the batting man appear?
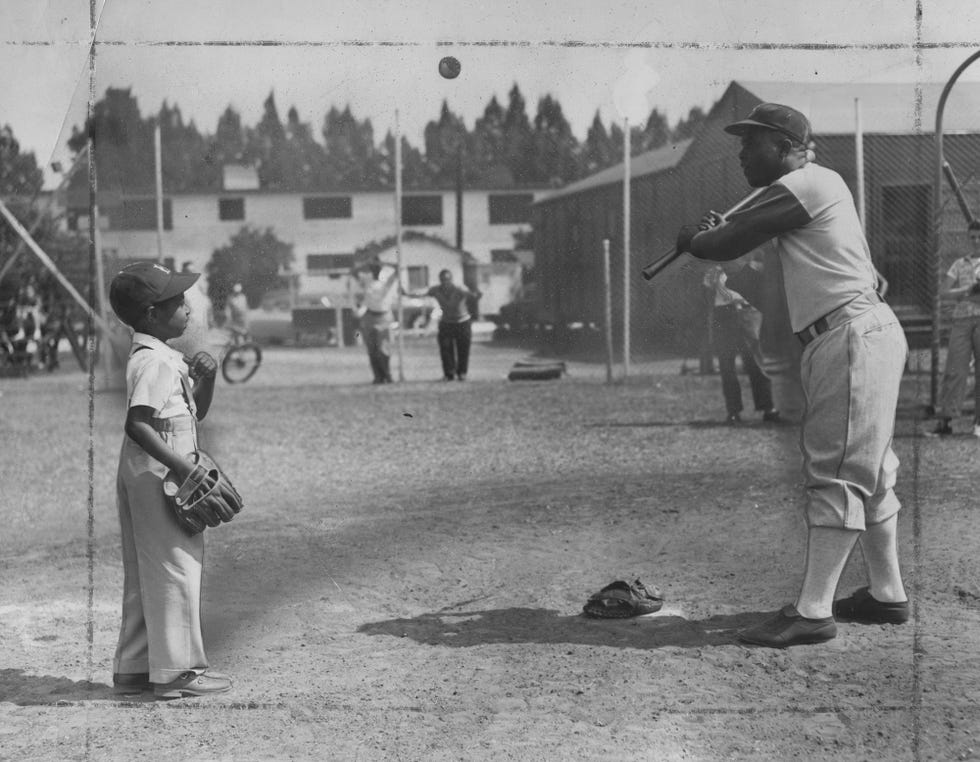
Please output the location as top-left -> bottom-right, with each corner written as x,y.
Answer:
533,82 -> 980,354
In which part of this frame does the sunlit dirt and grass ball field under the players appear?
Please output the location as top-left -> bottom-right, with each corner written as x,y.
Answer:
0,340 -> 980,760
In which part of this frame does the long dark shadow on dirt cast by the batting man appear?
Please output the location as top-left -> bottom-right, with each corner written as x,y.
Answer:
357,608 -> 771,648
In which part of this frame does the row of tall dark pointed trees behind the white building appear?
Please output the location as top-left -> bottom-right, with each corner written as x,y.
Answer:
68,83 -> 705,193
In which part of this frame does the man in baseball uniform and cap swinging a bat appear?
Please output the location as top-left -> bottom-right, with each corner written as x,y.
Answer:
677,103 -> 909,648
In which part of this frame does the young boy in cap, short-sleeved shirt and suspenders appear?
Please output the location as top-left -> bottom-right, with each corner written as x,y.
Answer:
109,262 -> 231,698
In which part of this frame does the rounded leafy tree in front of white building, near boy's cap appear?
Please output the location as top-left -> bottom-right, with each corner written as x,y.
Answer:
206,225 -> 294,310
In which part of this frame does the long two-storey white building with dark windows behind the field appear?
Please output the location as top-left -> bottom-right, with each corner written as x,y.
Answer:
69,167 -> 546,315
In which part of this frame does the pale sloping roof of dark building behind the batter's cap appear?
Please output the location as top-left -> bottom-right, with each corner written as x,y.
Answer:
737,81 -> 980,138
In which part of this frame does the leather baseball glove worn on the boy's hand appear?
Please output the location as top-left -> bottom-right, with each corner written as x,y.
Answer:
163,450 -> 243,536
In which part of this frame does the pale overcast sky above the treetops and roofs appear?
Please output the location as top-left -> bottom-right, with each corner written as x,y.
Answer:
0,0 -> 980,186
